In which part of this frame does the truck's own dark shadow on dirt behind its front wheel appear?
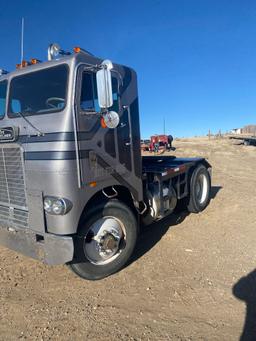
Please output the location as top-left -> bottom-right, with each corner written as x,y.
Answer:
130,186 -> 222,266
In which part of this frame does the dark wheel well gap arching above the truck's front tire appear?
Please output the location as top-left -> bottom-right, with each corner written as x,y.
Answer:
78,185 -> 138,228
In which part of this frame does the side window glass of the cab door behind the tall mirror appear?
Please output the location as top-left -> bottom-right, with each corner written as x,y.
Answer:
80,72 -> 119,112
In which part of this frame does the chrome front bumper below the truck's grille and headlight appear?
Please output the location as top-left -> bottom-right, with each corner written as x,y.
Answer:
0,227 -> 74,265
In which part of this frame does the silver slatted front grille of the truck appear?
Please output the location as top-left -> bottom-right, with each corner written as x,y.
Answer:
0,145 -> 28,227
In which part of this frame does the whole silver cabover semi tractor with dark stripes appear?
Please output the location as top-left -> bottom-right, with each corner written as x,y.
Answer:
0,44 -> 211,280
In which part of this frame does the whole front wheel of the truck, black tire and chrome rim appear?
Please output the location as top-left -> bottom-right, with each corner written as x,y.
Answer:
69,200 -> 138,280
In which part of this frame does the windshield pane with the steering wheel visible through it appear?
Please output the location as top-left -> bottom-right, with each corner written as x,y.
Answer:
8,65 -> 68,117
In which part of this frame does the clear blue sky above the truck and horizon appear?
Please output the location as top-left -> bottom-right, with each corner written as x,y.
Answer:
0,0 -> 256,138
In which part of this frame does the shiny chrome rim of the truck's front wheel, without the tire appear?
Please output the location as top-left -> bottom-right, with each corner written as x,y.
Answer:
84,216 -> 126,265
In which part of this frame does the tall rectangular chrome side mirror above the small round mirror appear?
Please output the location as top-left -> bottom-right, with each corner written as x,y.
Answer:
96,60 -> 113,109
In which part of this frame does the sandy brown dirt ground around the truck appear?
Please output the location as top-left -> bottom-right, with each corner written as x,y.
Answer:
0,138 -> 256,341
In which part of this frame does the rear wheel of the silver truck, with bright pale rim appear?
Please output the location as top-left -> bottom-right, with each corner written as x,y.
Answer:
187,164 -> 211,213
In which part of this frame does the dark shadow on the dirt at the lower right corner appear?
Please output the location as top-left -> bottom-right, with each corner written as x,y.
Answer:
233,270 -> 256,341
